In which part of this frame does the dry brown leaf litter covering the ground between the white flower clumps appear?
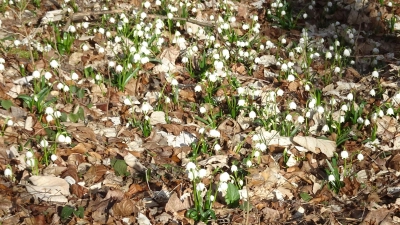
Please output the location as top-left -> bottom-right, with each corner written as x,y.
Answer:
0,0 -> 400,225
